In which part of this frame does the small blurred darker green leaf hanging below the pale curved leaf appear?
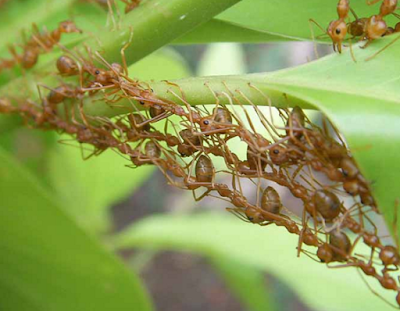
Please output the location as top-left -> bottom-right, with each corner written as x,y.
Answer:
211,256 -> 277,311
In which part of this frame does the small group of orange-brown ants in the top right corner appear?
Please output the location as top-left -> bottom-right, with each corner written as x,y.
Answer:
310,0 -> 400,59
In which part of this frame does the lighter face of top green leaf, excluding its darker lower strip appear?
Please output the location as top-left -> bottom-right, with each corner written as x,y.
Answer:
216,0 -> 397,42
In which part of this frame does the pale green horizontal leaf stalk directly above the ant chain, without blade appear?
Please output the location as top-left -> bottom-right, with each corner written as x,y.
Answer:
84,74 -> 313,117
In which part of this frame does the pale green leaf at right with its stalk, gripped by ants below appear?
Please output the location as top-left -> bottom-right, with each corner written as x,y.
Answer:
145,36 -> 400,240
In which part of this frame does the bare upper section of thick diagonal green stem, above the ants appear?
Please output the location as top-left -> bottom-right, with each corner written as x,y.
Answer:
98,0 -> 245,65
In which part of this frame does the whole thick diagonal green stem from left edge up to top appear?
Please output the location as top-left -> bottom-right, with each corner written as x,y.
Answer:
0,0 -> 240,99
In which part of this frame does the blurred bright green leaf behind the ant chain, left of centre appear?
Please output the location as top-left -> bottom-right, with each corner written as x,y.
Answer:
47,144 -> 154,233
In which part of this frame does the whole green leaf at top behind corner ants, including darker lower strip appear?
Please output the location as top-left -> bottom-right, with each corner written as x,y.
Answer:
176,0 -> 398,44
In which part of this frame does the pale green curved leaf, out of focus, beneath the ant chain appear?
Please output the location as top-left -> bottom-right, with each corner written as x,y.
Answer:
114,213 -> 395,311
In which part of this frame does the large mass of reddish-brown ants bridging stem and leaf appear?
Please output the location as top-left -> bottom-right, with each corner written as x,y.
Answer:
0,40 -> 400,306
